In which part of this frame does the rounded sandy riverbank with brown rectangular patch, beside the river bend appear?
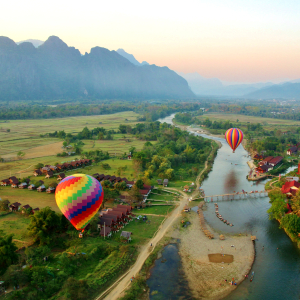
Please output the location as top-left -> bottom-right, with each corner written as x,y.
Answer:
171,212 -> 255,299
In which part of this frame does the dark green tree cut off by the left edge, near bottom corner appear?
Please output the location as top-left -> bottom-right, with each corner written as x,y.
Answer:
0,230 -> 18,268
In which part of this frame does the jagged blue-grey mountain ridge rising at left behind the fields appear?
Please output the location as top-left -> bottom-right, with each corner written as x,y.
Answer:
0,36 -> 195,100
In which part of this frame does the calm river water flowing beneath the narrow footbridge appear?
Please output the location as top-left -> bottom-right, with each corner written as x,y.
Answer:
149,115 -> 300,300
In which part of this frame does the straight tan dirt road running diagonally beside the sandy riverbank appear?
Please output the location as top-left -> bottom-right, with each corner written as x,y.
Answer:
95,193 -> 188,300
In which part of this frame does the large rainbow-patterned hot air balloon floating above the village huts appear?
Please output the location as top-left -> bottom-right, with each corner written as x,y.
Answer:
55,174 -> 104,230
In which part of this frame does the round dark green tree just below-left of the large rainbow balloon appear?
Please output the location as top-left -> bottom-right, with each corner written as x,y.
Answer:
28,206 -> 60,245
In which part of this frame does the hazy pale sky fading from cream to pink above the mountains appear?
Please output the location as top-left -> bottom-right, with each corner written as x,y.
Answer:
0,0 -> 300,82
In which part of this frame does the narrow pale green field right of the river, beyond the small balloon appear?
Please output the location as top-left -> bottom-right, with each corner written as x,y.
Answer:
197,113 -> 300,130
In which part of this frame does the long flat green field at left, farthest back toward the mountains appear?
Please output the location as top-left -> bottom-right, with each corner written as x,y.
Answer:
0,112 -> 139,156
